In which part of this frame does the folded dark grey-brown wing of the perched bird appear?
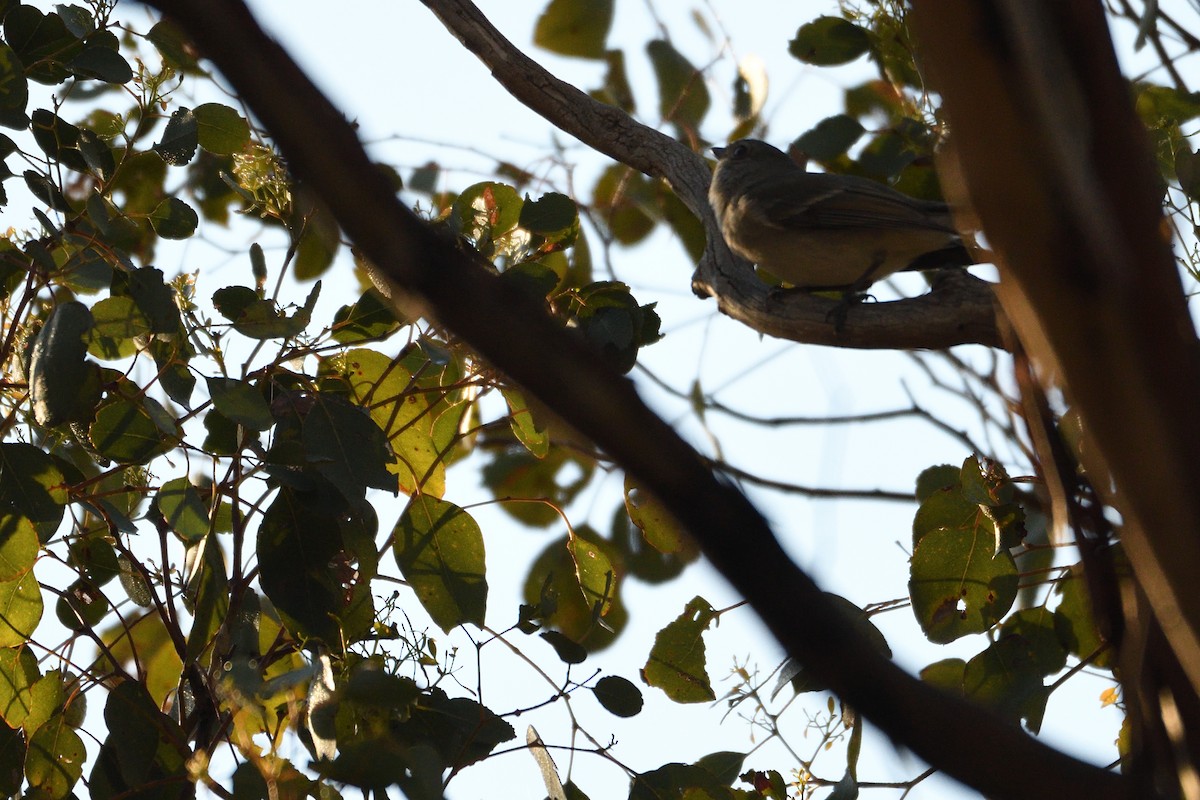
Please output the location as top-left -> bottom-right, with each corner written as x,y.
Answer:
755,173 -> 954,233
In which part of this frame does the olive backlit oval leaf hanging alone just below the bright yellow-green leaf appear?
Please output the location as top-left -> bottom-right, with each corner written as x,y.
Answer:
392,494 -> 487,632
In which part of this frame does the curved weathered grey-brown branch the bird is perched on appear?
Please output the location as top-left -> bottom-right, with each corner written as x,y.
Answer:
421,0 -> 1001,349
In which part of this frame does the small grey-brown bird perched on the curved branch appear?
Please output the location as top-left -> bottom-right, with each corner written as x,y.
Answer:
708,139 -> 973,291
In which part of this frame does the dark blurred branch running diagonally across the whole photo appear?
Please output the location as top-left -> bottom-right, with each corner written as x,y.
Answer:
136,0 -> 1147,800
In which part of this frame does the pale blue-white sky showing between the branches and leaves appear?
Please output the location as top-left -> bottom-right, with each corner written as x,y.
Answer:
9,0 -> 1190,800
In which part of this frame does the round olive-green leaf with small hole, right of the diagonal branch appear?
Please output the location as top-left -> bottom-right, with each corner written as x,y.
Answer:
908,529 -> 1018,644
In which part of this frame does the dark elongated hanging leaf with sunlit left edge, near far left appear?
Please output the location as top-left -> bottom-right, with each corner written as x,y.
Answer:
29,300 -> 98,426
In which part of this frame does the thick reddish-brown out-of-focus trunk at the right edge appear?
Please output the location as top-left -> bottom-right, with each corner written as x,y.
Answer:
914,0 -> 1200,705
